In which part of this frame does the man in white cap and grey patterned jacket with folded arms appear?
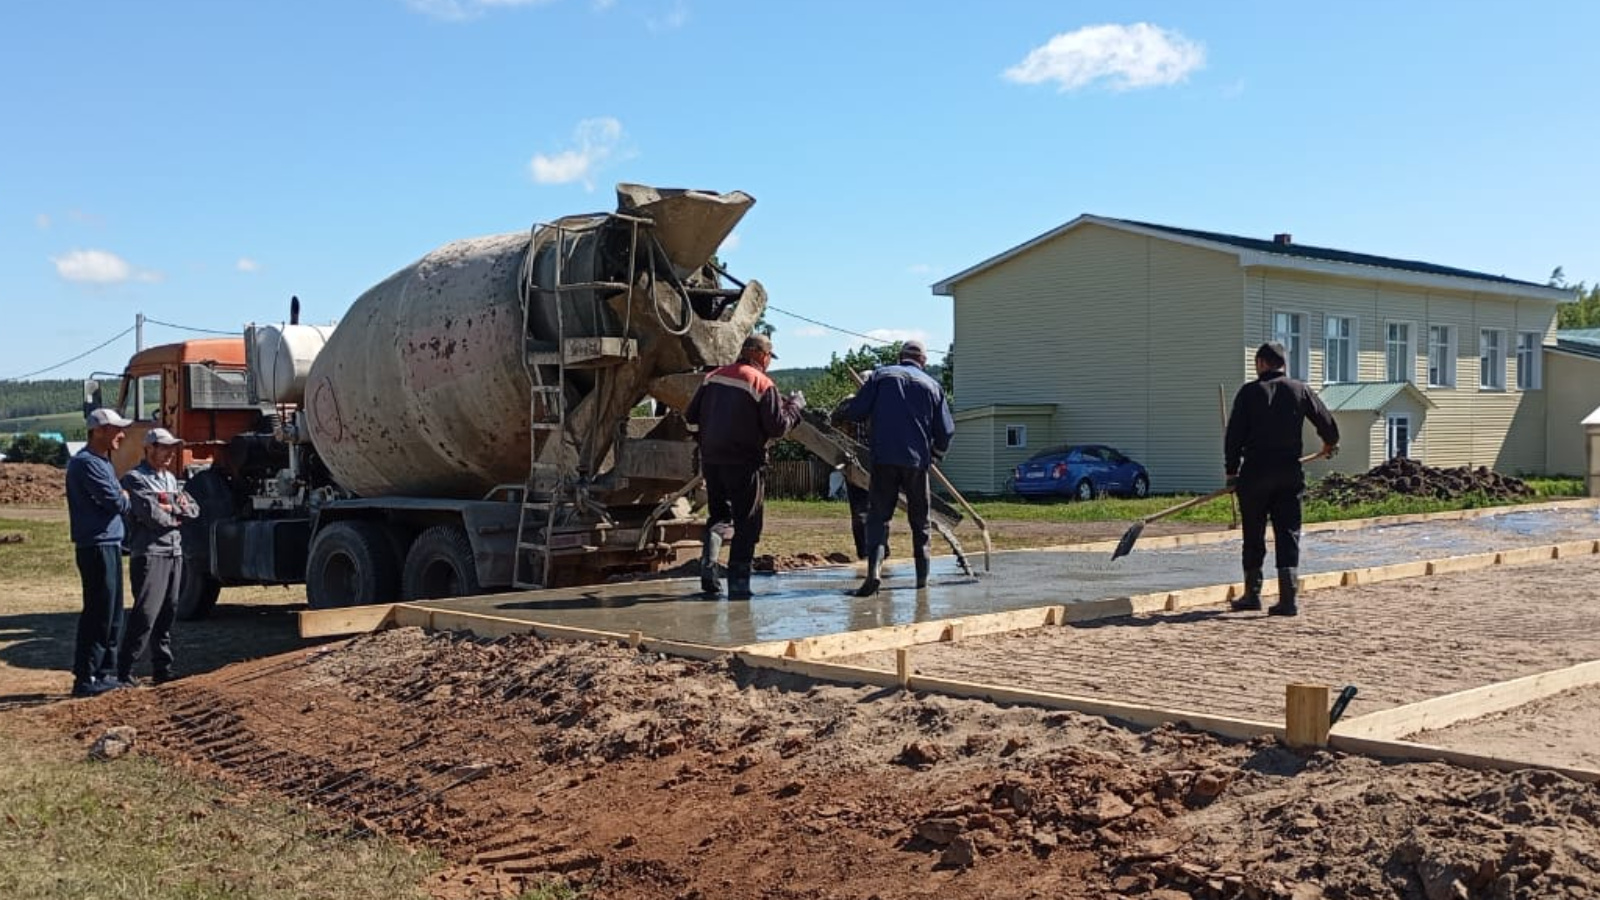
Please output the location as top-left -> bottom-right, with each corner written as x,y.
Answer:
117,428 -> 200,687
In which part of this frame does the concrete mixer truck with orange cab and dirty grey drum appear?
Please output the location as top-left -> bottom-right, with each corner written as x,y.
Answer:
85,184 -> 766,618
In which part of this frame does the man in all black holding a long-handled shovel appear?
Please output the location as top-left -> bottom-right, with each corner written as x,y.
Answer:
1224,341 -> 1339,615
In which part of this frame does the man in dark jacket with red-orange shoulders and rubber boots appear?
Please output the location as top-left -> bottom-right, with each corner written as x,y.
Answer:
683,335 -> 805,601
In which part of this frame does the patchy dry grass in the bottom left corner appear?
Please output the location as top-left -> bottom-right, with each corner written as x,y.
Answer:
0,719 -> 440,900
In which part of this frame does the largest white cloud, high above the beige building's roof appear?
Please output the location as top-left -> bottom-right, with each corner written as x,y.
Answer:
1005,22 -> 1205,91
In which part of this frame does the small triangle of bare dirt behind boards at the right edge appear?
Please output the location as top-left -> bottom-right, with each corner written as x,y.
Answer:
1406,685 -> 1600,769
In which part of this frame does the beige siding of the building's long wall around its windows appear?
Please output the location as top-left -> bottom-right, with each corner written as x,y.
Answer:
1245,269 -> 1555,474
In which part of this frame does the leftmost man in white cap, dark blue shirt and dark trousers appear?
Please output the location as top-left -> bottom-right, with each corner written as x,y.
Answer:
67,408 -> 133,697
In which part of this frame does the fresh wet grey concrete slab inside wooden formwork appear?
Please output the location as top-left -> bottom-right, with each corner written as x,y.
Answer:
419,508 -> 1600,647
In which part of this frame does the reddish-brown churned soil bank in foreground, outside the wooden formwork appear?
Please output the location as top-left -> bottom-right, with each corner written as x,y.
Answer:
50,629 -> 1600,900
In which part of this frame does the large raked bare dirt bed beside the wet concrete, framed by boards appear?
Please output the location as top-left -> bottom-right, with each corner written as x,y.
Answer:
830,556 -> 1600,723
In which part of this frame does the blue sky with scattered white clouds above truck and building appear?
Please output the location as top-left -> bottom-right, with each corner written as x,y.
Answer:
0,0 -> 1600,378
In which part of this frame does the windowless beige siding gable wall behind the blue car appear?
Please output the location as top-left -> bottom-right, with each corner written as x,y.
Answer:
950,226 -> 1243,492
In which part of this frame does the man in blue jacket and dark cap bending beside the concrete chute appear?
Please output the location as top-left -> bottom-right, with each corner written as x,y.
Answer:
834,341 -> 955,597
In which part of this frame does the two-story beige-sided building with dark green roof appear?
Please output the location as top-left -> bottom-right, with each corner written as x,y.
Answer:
933,215 -> 1576,493
